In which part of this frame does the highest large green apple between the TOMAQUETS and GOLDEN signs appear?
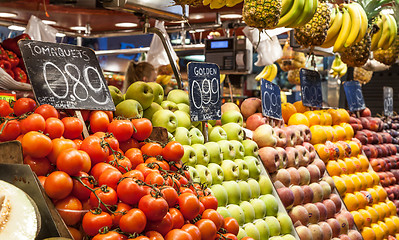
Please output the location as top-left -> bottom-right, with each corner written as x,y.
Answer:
125,81 -> 154,110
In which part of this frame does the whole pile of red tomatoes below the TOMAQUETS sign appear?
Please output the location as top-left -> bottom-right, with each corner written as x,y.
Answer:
0,98 -> 247,240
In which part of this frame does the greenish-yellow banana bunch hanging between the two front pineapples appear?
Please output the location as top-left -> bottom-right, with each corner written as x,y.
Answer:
276,0 -> 318,28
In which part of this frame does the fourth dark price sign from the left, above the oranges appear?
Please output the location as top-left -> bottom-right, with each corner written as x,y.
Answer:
299,68 -> 323,107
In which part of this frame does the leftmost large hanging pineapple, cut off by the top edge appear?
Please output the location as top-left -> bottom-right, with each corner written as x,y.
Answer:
242,0 -> 281,29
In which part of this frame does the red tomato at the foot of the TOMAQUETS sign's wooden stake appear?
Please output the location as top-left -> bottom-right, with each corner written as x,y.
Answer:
80,135 -> 109,164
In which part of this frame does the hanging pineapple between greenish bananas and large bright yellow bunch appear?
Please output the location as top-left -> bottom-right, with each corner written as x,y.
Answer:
294,1 -> 331,47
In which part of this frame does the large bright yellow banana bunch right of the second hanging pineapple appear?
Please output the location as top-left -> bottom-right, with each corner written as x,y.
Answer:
321,2 -> 368,52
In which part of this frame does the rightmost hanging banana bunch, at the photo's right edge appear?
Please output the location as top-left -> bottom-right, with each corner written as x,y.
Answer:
371,13 -> 398,51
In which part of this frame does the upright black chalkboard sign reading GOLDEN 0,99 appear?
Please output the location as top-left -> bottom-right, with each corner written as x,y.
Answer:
187,62 -> 222,121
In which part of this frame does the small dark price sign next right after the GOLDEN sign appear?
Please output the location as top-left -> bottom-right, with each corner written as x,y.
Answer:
260,79 -> 282,120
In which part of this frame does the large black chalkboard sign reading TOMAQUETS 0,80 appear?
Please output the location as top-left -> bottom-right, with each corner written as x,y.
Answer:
18,40 -> 115,111
